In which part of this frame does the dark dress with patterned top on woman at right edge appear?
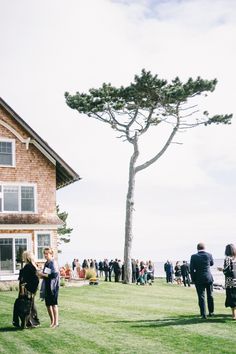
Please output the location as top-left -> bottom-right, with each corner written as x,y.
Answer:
223,257 -> 236,308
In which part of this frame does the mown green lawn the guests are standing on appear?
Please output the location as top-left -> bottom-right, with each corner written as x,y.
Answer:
0,280 -> 236,354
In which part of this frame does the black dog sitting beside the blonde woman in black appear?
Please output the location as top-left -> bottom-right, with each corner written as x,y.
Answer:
13,295 -> 32,329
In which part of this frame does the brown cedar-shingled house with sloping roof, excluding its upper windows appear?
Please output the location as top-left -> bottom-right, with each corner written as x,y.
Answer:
0,99 -> 79,280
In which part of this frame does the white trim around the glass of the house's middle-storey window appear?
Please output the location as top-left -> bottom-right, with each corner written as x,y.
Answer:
0,181 -> 38,214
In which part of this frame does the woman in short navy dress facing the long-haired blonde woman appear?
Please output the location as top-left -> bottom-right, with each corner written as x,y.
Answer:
39,247 -> 60,328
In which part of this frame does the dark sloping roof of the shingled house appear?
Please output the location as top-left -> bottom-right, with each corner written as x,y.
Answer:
0,97 -> 81,189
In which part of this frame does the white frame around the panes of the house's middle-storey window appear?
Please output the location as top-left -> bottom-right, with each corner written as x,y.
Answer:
0,181 -> 38,214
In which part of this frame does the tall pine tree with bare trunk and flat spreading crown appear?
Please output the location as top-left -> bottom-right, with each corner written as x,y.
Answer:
65,69 -> 232,283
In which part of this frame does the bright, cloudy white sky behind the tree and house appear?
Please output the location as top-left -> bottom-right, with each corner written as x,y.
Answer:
0,0 -> 236,264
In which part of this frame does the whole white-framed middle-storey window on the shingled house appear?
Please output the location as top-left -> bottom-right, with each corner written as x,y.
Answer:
0,184 -> 36,213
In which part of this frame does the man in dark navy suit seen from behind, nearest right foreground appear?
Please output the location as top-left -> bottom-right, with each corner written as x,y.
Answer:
190,243 -> 214,319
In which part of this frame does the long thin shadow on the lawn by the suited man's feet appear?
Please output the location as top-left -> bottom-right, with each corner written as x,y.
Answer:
109,314 -> 231,328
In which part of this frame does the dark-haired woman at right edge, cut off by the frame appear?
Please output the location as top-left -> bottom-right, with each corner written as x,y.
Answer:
218,244 -> 236,320
